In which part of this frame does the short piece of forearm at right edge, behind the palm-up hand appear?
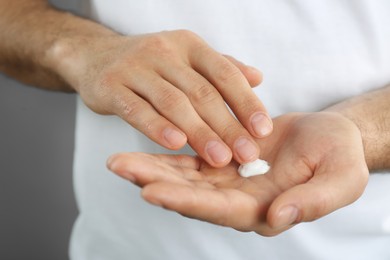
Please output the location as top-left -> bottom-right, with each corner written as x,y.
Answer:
326,86 -> 390,171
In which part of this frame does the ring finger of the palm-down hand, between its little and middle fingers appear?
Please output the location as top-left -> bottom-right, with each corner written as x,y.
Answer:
128,72 -> 232,167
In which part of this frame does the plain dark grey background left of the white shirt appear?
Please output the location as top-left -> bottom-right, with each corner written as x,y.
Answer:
0,0 -> 78,260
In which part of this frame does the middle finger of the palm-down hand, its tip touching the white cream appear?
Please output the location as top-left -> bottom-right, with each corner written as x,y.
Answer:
162,65 -> 259,163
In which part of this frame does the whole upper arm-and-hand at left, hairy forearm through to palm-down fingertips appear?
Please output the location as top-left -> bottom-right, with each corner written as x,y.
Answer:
0,0 -> 272,167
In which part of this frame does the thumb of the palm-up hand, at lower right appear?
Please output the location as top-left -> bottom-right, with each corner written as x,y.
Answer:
268,157 -> 368,228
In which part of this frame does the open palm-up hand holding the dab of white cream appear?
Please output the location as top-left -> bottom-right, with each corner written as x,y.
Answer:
108,112 -> 368,236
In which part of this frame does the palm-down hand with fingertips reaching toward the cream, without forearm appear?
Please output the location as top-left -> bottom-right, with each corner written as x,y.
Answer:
53,31 -> 272,167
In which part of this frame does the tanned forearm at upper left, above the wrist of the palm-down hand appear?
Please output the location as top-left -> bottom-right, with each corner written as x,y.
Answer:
0,0 -> 114,91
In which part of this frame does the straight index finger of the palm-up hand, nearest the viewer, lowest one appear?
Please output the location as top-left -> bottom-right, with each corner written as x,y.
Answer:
142,183 -> 261,231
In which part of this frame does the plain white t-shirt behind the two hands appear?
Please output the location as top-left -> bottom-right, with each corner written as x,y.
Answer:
70,0 -> 390,260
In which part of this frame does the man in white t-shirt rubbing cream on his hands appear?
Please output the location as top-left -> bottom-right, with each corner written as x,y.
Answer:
0,0 -> 390,259
